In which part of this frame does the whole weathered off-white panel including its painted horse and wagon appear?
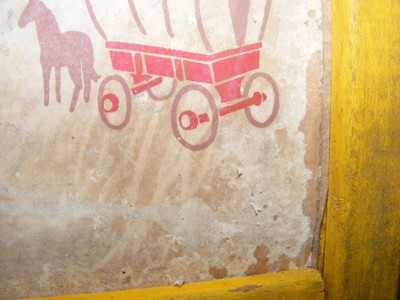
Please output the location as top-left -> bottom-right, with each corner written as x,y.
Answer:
0,0 -> 329,300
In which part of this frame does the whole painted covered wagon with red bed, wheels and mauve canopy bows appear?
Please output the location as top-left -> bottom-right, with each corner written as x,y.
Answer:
86,0 -> 279,150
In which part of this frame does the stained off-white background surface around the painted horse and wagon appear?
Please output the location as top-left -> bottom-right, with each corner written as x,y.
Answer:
0,0 -> 329,299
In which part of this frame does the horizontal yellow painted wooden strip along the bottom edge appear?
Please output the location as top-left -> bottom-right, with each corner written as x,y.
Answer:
19,269 -> 324,300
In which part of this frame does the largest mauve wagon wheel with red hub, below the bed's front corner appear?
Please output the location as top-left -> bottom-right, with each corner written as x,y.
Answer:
171,84 -> 219,151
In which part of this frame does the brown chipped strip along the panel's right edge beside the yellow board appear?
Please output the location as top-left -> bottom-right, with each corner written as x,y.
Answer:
299,51 -> 329,267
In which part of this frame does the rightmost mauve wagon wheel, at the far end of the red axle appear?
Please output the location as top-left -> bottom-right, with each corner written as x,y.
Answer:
243,72 -> 279,128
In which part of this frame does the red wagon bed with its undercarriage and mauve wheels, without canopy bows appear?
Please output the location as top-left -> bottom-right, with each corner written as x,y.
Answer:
98,41 -> 279,150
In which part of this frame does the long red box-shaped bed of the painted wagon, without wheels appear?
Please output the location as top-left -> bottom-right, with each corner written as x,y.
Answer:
106,42 -> 262,84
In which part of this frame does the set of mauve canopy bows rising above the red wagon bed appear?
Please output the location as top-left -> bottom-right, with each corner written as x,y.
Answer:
85,0 -> 272,52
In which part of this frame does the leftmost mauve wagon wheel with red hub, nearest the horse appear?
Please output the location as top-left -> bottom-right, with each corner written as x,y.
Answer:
97,75 -> 132,130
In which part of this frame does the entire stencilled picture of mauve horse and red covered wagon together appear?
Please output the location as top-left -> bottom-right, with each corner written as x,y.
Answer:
18,0 -> 279,150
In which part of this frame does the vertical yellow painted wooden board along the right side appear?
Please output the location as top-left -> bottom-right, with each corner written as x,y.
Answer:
323,0 -> 400,299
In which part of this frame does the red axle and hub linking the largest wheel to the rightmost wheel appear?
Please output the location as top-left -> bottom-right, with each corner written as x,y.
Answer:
179,92 -> 267,130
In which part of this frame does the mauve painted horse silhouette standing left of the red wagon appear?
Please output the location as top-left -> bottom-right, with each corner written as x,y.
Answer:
18,0 -> 100,112
